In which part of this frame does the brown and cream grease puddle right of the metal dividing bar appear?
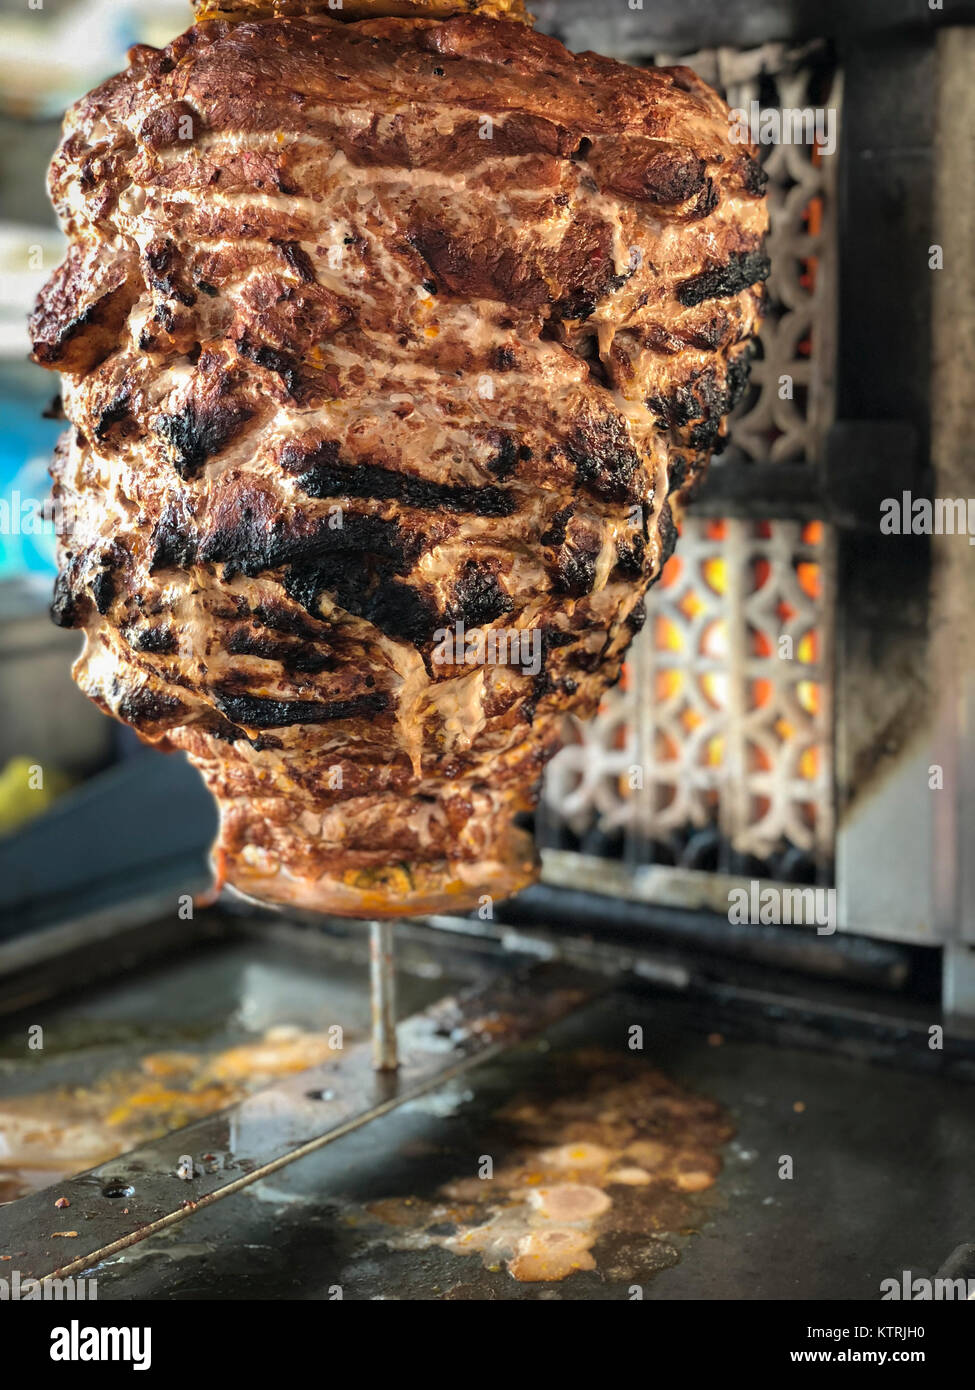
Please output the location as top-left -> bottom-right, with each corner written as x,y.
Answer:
369,1051 -> 733,1297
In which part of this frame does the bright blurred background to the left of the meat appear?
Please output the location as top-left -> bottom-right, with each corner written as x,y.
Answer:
0,0 -> 189,834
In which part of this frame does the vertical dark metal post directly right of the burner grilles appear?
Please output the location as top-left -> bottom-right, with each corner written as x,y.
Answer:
828,35 -> 937,944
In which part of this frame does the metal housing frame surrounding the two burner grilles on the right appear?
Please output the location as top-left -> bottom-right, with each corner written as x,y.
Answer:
537,10 -> 975,989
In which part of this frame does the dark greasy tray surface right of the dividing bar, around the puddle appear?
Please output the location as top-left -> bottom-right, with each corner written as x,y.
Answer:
38,994 -> 975,1301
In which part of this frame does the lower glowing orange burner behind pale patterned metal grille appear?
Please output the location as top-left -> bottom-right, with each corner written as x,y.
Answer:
545,516 -> 833,867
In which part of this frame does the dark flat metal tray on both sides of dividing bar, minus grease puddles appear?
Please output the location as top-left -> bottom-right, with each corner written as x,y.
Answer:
0,911 -> 975,1301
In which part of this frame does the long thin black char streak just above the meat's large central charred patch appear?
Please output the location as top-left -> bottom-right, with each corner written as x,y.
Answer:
281,439 -> 517,517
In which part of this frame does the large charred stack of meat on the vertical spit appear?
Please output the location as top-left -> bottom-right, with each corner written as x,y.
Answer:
32,0 -> 768,916
